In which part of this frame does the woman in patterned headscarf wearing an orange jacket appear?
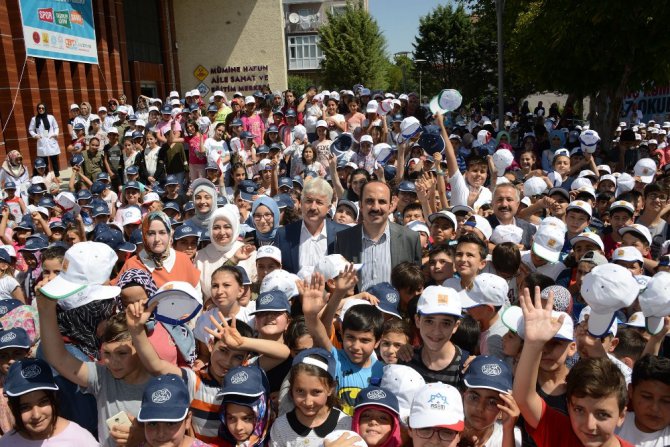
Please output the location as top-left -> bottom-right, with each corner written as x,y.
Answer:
115,211 -> 200,290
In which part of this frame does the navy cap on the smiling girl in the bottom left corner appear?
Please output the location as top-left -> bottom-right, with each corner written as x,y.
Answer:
5,358 -> 58,397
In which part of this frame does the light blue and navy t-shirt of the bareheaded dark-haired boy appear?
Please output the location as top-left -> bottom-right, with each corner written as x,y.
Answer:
330,347 -> 384,416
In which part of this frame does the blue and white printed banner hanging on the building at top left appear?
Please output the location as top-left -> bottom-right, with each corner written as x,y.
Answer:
19,0 -> 98,64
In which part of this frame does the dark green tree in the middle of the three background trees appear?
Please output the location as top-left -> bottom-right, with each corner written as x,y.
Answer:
414,4 -> 496,100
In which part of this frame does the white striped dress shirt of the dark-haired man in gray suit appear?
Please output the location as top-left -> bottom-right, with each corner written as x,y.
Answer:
359,223 -> 392,291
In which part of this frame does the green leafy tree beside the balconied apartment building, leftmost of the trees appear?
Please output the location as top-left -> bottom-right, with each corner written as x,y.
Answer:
319,0 -> 388,89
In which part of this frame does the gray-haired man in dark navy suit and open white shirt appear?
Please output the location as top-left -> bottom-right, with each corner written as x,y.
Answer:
274,178 -> 349,273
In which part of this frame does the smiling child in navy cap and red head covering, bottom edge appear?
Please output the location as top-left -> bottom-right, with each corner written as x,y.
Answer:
351,386 -> 402,447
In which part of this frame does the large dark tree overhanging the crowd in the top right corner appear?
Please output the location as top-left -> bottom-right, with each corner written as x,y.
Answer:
506,0 -> 670,150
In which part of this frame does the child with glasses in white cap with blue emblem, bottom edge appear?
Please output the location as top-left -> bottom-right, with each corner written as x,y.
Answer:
409,383 -> 465,447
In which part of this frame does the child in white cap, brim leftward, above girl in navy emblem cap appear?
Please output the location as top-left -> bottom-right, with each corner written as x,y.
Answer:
461,273 -> 509,358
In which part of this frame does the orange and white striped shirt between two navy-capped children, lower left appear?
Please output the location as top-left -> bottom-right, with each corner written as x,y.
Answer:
181,368 -> 223,445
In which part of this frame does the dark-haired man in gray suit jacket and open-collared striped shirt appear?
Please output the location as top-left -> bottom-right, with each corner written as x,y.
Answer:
334,181 -> 421,291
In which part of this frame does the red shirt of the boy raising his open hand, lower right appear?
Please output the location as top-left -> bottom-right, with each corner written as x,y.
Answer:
526,400 -> 633,447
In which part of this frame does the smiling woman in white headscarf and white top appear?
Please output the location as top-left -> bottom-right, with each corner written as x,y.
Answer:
195,204 -> 256,300
